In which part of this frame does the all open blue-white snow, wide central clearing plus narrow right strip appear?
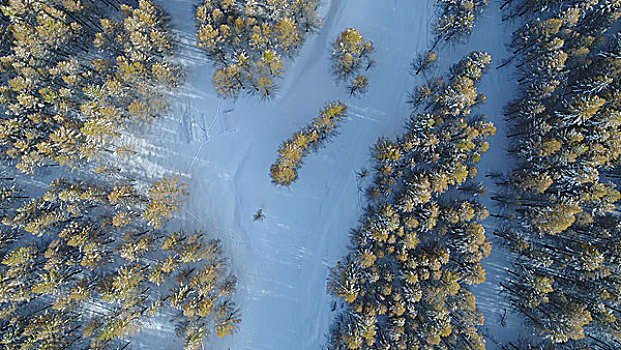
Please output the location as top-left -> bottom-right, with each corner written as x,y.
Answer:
132,0 -> 519,350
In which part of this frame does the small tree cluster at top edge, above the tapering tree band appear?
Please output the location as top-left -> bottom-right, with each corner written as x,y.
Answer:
432,0 -> 486,50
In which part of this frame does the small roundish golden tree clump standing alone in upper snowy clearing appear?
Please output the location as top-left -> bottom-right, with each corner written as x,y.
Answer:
332,28 -> 375,95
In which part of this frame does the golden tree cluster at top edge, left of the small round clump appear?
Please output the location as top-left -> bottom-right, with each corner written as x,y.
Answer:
196,0 -> 320,97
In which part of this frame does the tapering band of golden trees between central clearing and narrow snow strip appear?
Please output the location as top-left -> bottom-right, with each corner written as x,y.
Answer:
327,52 -> 495,350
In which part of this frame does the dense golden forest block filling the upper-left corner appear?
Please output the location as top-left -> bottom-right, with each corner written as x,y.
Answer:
0,0 -> 179,174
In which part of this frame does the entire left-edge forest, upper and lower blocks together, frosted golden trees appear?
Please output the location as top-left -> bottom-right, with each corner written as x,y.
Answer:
0,0 -> 240,349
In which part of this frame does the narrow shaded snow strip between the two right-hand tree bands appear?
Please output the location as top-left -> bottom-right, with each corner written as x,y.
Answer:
458,5 -> 523,350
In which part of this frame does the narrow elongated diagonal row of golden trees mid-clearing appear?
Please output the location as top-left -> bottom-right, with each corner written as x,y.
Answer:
270,102 -> 347,186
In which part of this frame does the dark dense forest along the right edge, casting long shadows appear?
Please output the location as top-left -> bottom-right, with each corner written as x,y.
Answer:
495,0 -> 621,350
